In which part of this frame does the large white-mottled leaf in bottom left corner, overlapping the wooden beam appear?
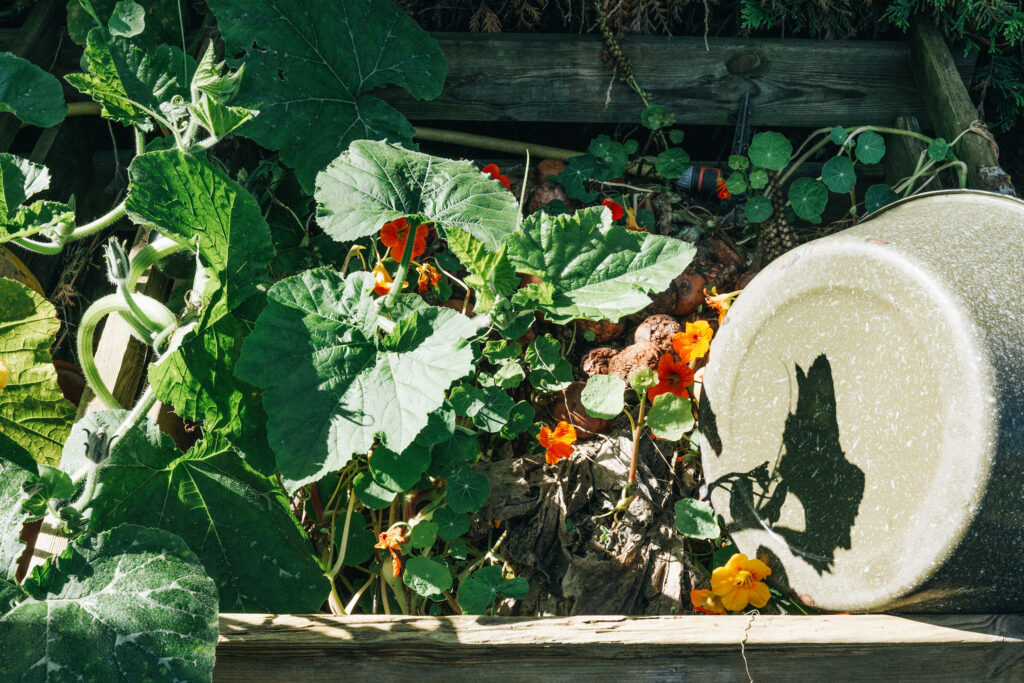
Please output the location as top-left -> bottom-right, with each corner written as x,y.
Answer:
0,524 -> 217,681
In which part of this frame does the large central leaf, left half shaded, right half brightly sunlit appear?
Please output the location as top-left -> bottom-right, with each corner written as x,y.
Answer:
236,268 -> 475,490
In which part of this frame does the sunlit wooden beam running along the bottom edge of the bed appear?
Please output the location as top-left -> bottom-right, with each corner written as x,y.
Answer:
214,614 -> 1024,683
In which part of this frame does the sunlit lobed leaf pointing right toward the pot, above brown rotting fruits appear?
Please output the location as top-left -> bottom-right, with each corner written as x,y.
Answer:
508,207 -> 695,323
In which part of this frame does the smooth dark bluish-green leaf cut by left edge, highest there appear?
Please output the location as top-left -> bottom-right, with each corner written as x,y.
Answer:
0,52 -> 68,128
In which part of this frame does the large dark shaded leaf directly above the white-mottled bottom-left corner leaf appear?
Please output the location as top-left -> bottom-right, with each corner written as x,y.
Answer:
62,411 -> 330,613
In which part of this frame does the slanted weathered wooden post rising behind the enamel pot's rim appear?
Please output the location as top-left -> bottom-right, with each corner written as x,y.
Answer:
910,22 -> 1013,194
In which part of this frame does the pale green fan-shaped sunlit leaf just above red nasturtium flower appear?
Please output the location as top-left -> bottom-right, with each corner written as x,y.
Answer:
316,140 -> 518,251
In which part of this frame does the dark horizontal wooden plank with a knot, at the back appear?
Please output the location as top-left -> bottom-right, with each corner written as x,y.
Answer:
383,34 -> 974,127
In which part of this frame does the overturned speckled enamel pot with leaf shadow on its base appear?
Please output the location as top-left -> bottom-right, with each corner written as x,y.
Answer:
700,190 -> 1024,612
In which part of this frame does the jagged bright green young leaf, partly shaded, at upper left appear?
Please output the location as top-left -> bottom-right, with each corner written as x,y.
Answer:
65,27 -> 196,130
